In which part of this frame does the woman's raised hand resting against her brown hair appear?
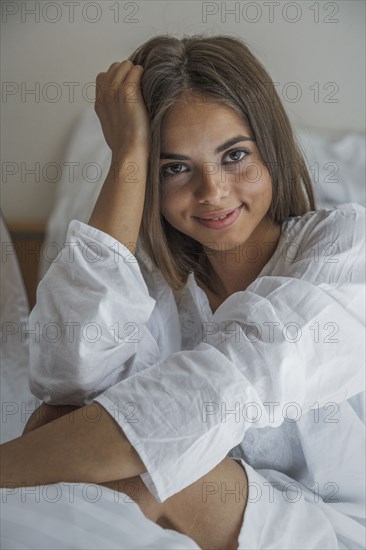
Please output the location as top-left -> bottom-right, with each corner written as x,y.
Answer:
94,59 -> 150,158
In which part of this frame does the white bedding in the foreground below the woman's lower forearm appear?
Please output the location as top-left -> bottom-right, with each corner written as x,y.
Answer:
1,483 -> 199,550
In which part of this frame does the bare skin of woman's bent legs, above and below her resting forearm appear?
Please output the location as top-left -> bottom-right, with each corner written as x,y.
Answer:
23,403 -> 248,550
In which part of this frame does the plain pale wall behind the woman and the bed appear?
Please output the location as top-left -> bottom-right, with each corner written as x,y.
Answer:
1,0 -> 365,222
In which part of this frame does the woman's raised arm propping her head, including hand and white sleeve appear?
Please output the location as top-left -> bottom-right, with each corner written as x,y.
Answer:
29,61 -> 169,406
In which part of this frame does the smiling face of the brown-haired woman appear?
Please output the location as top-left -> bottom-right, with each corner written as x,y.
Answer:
160,96 -> 272,250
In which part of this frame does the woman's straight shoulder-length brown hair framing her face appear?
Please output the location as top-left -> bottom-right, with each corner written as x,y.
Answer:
129,34 -> 316,290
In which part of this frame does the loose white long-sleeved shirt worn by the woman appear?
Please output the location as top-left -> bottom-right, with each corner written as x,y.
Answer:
29,203 -> 365,548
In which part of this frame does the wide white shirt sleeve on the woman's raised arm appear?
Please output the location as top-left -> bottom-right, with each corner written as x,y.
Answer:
28,220 -> 180,406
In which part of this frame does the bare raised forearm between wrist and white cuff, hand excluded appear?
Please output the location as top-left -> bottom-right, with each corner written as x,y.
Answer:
89,149 -> 148,254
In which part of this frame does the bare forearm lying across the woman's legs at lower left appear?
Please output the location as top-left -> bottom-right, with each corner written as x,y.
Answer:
0,402 -> 146,487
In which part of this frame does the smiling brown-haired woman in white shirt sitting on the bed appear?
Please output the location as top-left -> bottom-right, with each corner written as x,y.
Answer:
3,35 -> 364,549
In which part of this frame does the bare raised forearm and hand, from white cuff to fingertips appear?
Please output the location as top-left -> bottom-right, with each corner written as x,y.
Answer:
89,60 -> 150,254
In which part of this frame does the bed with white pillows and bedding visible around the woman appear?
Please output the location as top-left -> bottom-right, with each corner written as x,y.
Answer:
0,109 -> 365,549
